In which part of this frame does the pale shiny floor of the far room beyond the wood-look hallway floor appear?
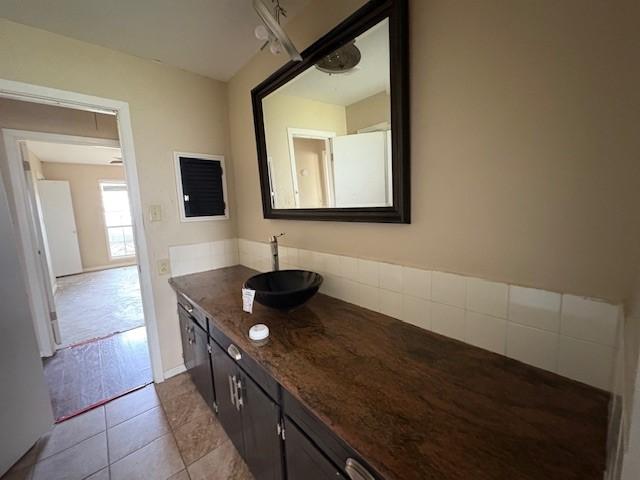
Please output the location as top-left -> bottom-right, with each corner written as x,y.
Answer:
55,265 -> 144,347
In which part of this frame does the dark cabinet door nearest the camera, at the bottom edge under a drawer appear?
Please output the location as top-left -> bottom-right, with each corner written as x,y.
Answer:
284,417 -> 346,480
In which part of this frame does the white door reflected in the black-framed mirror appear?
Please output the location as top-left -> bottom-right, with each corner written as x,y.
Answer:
331,132 -> 390,207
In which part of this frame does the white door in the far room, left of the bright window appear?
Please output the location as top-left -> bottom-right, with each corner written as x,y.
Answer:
38,180 -> 82,277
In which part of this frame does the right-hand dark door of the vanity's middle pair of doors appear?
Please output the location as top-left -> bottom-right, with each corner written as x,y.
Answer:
241,374 -> 282,480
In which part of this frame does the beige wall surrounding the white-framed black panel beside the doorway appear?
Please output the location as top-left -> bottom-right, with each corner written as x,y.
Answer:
0,20 -> 237,370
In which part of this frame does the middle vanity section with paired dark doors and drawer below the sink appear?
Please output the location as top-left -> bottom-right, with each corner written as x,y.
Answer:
211,340 -> 283,480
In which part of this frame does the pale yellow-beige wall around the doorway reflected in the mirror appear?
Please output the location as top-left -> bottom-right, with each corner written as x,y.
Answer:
264,94 -> 347,208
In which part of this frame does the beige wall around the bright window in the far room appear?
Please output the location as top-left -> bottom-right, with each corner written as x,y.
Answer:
42,162 -> 129,270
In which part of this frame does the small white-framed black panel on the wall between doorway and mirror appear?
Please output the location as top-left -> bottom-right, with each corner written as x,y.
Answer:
174,152 -> 229,222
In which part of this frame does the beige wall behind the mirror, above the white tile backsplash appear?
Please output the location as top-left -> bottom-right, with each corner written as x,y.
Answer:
229,0 -> 640,301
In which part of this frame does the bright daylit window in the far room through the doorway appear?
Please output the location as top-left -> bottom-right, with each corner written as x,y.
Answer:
100,182 -> 136,258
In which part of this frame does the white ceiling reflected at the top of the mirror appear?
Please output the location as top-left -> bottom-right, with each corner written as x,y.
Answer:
276,20 -> 390,106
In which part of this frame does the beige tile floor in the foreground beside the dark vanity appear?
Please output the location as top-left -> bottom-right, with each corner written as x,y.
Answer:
1,374 -> 253,480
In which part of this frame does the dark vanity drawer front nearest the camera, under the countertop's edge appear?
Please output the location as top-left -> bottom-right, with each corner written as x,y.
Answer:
282,389 -> 382,479
